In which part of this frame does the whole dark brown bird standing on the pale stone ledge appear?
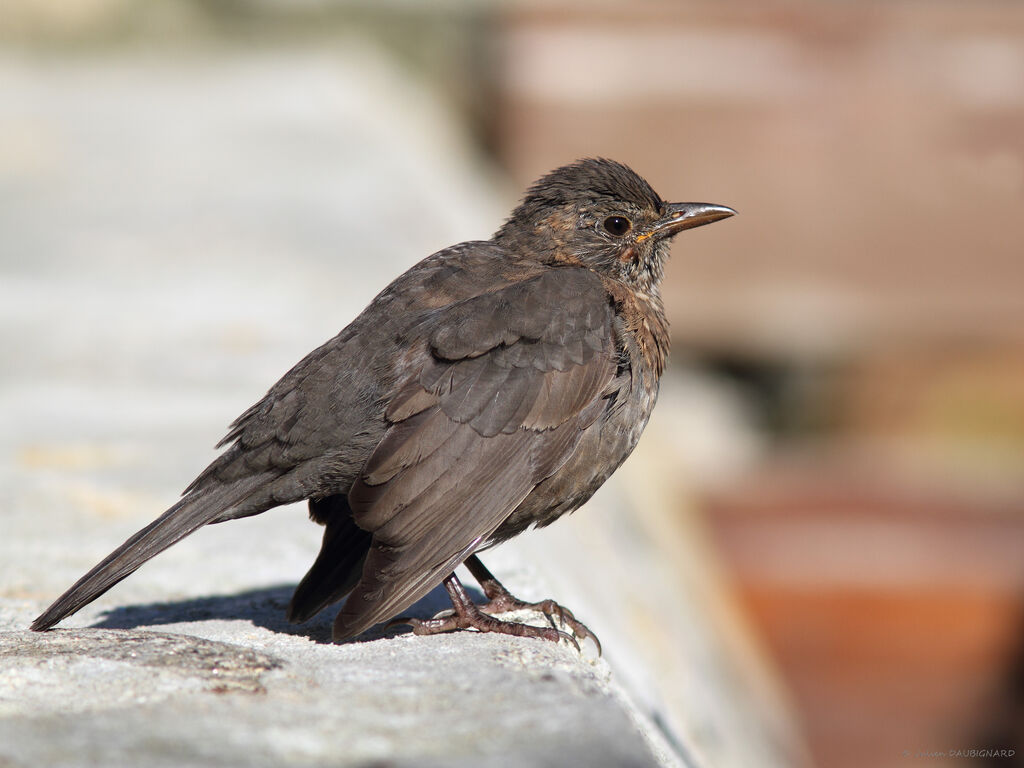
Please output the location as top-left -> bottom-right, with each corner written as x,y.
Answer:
32,158 -> 735,650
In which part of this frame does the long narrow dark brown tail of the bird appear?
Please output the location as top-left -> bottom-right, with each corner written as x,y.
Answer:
32,478 -> 276,632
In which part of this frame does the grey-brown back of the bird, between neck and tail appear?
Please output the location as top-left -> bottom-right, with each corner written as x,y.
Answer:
186,242 -> 532,501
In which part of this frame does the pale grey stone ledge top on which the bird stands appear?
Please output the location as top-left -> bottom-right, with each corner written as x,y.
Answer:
0,42 -> 672,768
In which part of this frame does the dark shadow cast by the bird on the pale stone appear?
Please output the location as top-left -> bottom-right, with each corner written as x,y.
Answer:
92,585 -> 475,643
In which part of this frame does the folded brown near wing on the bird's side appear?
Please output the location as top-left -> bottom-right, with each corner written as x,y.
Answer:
335,267 -> 616,639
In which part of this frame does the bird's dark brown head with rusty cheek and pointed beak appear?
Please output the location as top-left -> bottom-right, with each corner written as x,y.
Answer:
495,158 -> 735,293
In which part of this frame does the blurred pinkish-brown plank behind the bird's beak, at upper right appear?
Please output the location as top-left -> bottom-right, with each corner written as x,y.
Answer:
496,0 -> 1024,356
